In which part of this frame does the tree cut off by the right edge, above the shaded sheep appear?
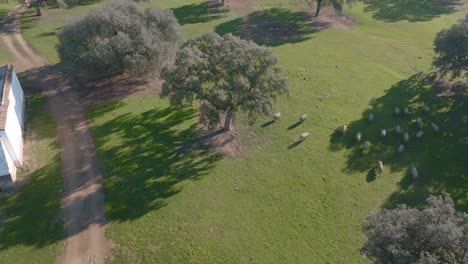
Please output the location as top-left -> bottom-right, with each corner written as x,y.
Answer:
433,16 -> 468,78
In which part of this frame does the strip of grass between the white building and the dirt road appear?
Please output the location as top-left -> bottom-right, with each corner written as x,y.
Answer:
0,95 -> 62,264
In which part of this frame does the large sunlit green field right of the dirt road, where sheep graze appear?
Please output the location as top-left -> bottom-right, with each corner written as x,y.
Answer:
23,0 -> 468,263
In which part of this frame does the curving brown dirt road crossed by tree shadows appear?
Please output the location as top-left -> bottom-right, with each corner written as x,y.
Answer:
0,4 -> 106,264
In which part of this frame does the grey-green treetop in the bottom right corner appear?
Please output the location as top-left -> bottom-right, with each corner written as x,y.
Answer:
363,196 -> 468,264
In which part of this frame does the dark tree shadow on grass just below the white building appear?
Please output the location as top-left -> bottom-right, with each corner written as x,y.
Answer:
0,155 -> 62,250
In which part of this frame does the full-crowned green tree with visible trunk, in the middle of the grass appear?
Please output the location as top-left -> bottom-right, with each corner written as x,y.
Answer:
162,33 -> 288,130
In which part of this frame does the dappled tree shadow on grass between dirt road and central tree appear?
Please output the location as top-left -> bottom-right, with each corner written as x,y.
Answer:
90,103 -> 222,221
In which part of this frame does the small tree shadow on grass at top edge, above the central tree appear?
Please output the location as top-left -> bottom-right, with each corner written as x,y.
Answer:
172,1 -> 227,25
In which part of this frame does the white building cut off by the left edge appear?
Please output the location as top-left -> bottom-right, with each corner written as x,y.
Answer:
0,65 -> 24,191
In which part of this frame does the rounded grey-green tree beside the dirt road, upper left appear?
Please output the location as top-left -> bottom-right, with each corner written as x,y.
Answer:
58,0 -> 181,79
